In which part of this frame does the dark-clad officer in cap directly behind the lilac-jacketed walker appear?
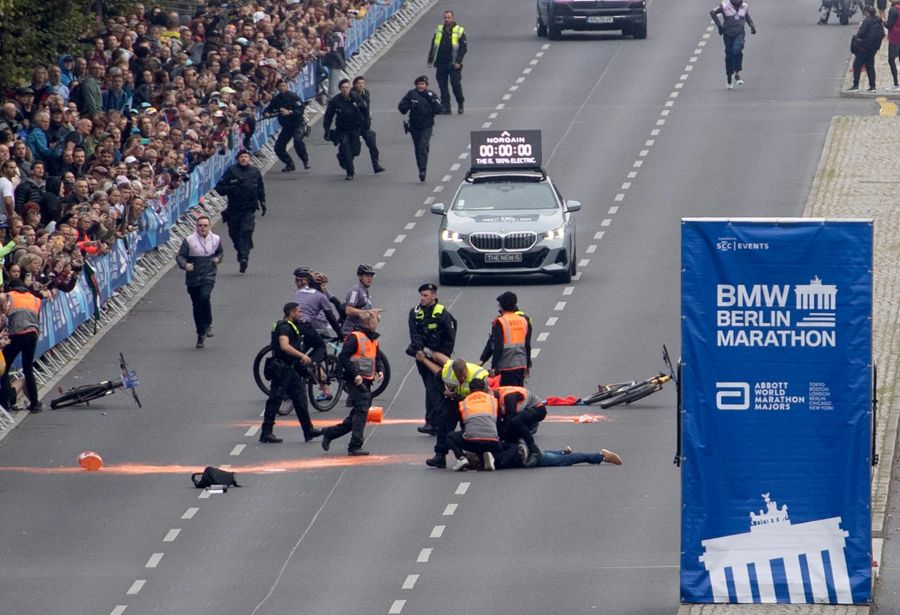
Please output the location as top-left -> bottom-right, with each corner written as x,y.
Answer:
216,150 -> 266,273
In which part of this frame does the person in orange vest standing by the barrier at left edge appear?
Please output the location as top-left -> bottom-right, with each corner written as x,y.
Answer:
0,278 -> 44,413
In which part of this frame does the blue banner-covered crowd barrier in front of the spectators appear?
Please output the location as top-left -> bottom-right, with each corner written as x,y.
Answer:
28,0 -> 405,357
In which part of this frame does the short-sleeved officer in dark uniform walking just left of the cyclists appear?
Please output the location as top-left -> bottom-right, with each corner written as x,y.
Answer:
259,301 -> 325,444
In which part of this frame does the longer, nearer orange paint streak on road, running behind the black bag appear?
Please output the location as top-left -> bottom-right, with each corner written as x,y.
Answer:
0,455 -> 422,476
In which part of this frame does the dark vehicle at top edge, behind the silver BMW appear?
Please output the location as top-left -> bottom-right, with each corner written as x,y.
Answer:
537,0 -> 647,41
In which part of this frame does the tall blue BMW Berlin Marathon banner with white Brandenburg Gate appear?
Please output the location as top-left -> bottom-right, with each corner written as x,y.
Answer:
681,219 -> 873,604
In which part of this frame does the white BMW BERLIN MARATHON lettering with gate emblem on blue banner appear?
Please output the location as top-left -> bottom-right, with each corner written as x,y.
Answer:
716,276 -> 838,348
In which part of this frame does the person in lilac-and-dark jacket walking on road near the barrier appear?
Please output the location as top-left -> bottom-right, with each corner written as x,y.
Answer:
175,215 -> 223,348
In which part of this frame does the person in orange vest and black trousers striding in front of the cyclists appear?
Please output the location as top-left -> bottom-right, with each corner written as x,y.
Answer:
322,311 -> 384,457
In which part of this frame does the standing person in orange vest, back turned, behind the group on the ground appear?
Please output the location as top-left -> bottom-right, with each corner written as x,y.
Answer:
480,291 -> 531,386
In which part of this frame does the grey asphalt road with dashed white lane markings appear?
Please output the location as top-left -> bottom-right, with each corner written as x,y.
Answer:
0,0 -> 870,615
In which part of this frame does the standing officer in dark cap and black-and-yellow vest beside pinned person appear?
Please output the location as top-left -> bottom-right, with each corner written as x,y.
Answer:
406,283 -> 456,436
